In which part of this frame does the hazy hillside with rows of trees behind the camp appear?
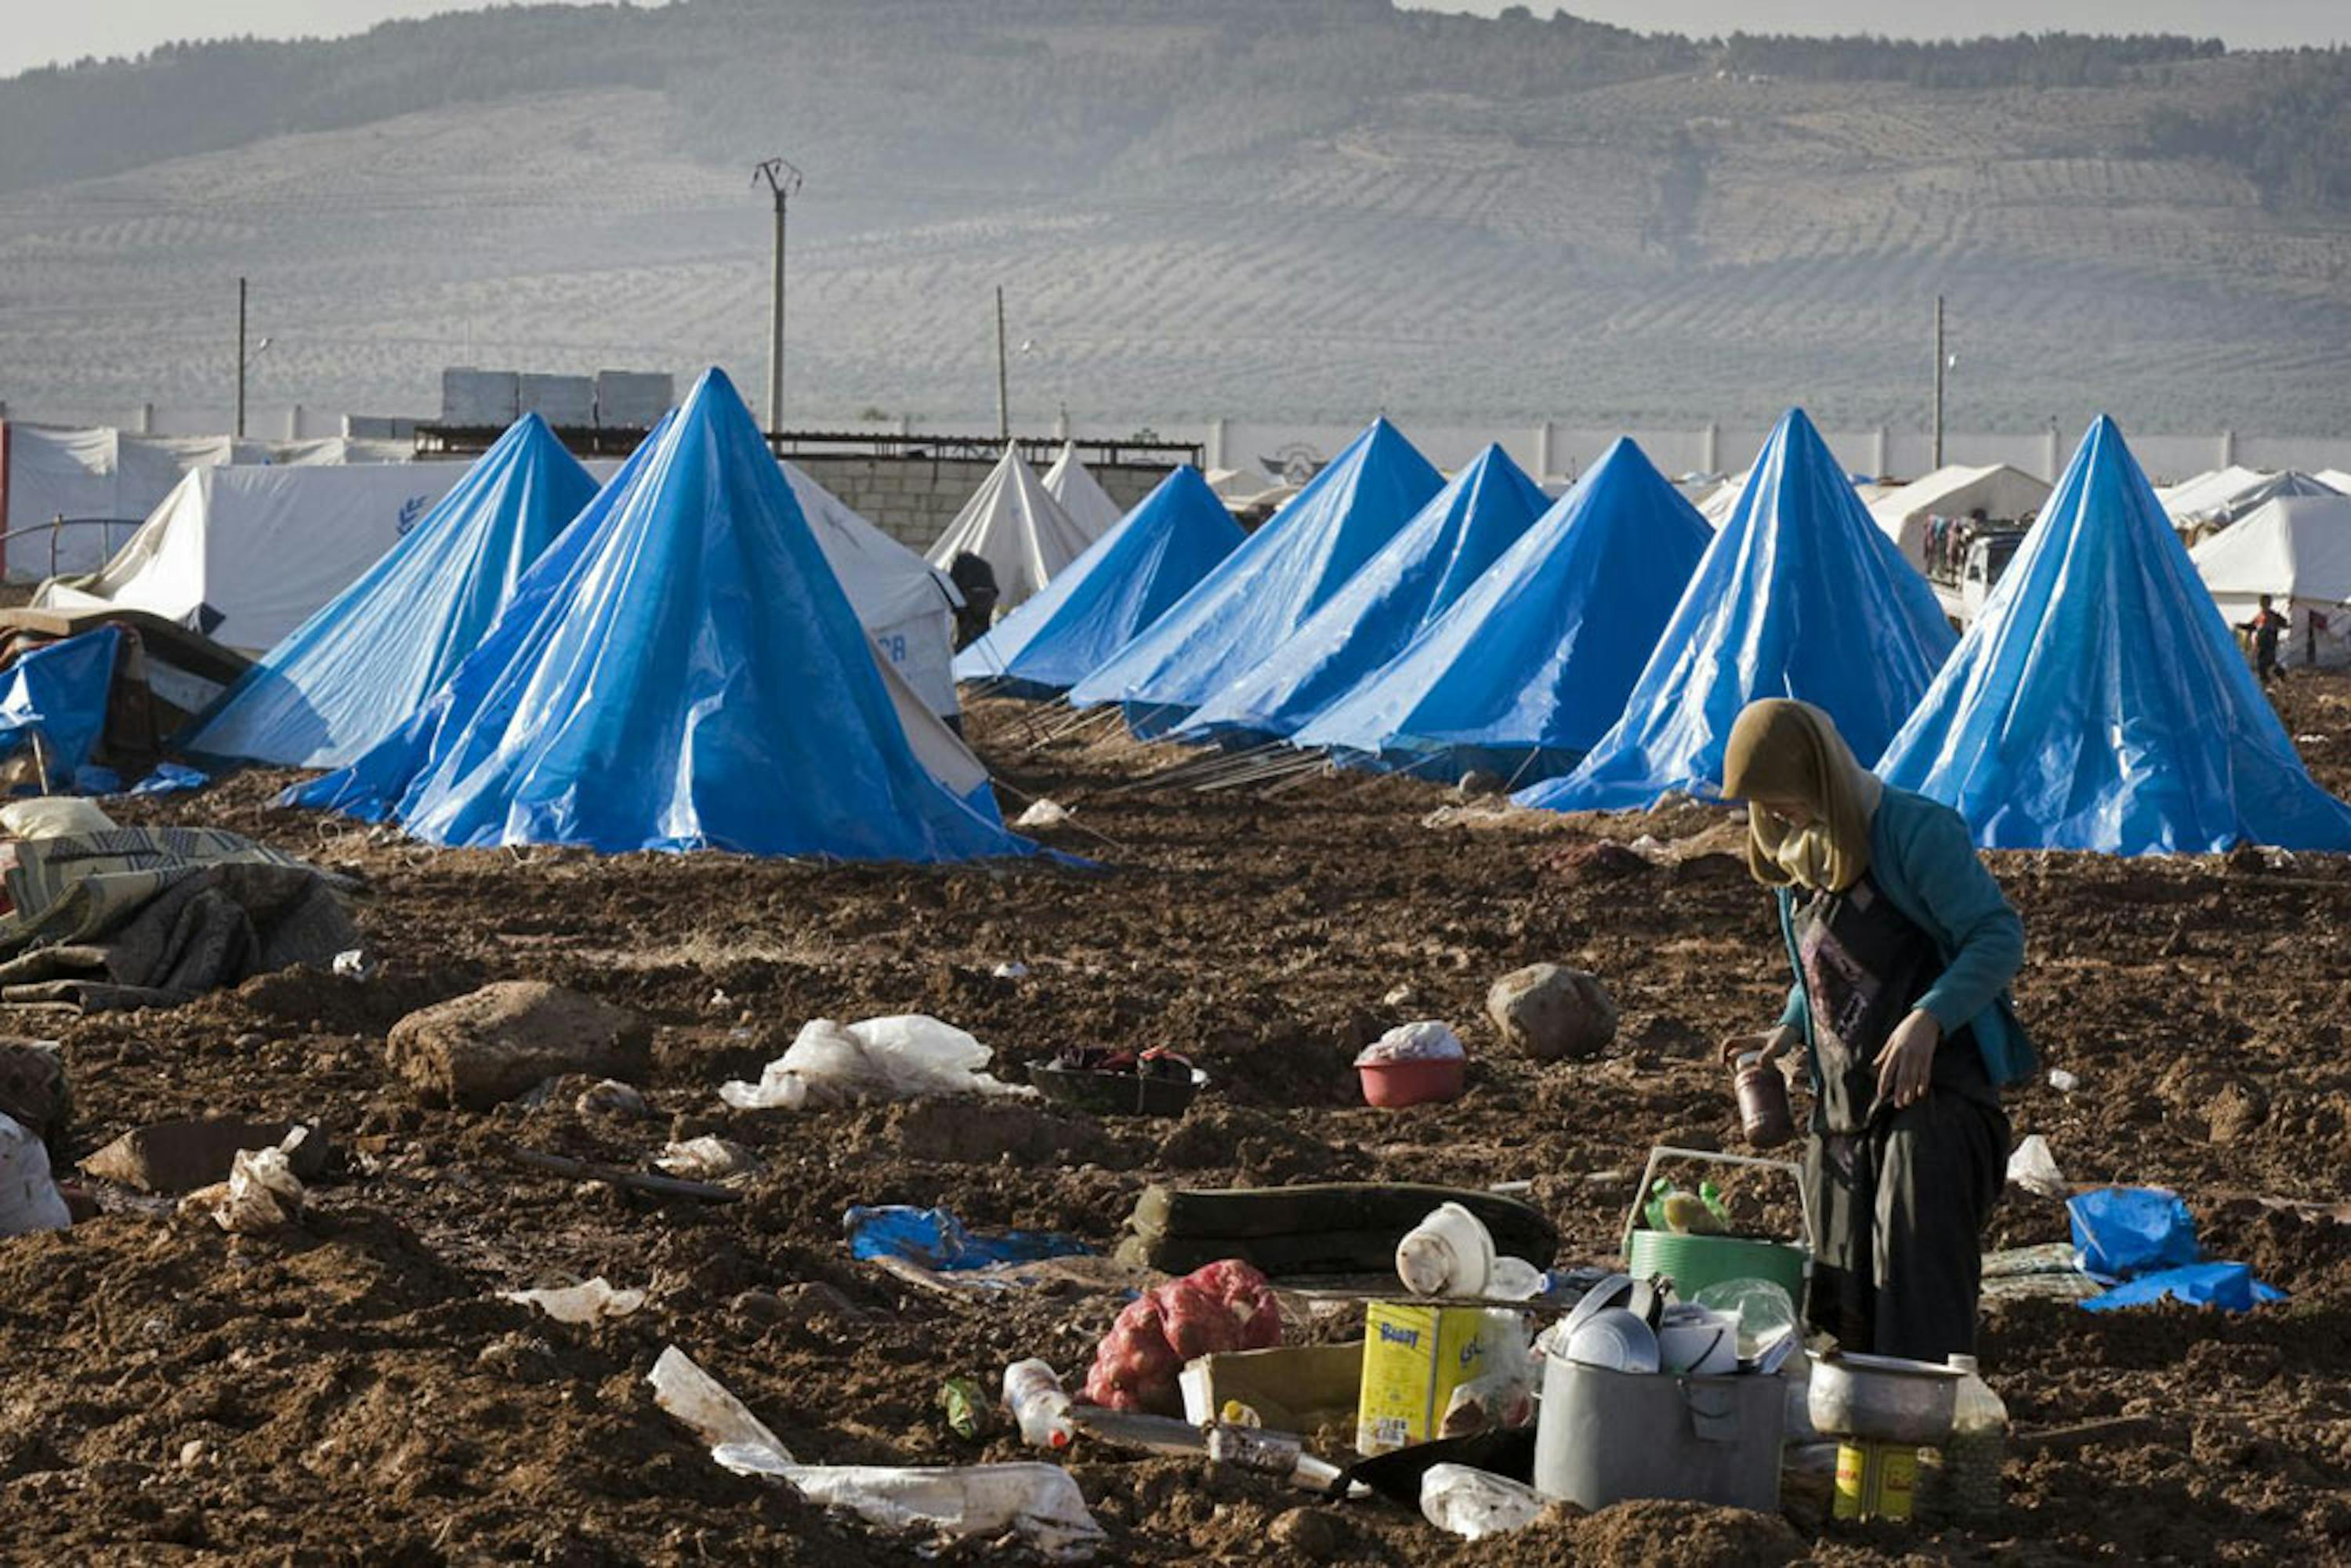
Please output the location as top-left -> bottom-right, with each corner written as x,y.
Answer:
0,0 -> 2351,433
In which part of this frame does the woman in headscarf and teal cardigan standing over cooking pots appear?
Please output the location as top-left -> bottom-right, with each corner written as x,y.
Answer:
1721,698 -> 2034,1361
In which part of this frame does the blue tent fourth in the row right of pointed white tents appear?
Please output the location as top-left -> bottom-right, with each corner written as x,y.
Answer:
1295,440 -> 1714,783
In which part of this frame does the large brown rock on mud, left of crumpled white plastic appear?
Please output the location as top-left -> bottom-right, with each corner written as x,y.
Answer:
386,980 -> 654,1110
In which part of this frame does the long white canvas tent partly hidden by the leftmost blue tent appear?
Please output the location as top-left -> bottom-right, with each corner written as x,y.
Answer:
33,463 -> 465,654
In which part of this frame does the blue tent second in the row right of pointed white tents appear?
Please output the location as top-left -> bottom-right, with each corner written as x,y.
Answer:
1070,418 -> 1444,736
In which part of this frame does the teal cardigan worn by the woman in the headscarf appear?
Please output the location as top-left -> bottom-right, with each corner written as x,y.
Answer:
1780,785 -> 2034,1084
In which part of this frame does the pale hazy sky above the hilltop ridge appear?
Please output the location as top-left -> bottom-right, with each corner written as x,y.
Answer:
0,0 -> 2351,75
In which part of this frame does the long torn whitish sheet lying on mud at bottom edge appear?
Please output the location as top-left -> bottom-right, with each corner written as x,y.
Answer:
647,1345 -> 1103,1561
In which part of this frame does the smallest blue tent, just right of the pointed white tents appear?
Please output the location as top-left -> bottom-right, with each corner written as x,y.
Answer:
955,463 -> 1246,696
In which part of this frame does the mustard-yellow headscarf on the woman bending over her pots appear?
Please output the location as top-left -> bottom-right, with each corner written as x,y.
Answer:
1723,696 -> 1886,893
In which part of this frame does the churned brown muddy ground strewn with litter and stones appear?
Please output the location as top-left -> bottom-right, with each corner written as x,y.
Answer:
0,677 -> 2351,1566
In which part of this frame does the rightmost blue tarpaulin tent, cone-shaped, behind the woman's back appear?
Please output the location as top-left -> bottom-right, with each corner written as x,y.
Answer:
1878,418 -> 2351,856
